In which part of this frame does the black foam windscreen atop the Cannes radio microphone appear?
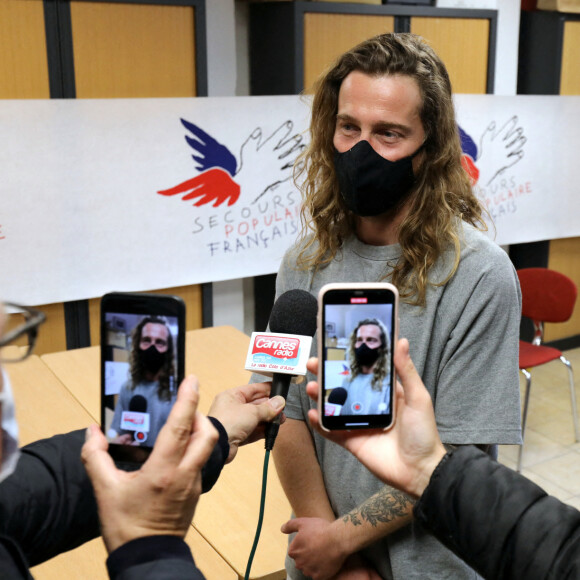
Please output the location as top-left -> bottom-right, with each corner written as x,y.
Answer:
268,290 -> 318,336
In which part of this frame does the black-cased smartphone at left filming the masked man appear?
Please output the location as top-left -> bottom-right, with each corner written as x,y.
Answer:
101,292 -> 185,469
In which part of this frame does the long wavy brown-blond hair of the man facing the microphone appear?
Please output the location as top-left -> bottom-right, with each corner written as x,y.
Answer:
295,33 -> 487,305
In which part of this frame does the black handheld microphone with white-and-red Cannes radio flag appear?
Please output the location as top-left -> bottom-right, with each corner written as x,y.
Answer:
245,289 -> 318,451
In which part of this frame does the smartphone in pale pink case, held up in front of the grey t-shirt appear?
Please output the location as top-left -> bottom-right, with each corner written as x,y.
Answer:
318,283 -> 399,431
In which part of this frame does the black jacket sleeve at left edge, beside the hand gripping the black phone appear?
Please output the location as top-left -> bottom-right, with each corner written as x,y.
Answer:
0,430 -> 100,566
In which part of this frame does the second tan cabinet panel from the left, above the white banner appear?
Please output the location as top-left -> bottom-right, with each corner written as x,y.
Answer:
71,2 -> 196,98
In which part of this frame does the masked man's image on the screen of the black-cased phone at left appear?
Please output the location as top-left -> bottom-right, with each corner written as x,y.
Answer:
109,317 -> 177,447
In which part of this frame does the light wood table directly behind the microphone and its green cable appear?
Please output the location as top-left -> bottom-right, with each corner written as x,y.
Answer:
41,326 -> 291,580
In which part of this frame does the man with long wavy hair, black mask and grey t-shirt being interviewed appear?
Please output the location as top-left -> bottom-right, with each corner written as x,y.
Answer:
274,33 -> 521,580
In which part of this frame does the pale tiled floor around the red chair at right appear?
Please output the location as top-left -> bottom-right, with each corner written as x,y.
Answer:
499,348 -> 580,509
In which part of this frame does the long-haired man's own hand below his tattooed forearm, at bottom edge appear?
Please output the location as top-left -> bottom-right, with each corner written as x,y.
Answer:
281,518 -> 348,580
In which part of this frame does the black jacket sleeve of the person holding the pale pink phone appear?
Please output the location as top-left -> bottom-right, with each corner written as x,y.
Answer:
414,446 -> 580,580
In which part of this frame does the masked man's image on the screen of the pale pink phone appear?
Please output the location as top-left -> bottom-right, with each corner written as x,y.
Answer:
341,318 -> 391,415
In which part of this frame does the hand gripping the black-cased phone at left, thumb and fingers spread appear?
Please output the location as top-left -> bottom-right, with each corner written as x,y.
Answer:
82,376 -> 218,553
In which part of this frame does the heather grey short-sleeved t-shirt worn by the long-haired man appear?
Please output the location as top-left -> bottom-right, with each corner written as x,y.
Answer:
272,224 -> 521,580
